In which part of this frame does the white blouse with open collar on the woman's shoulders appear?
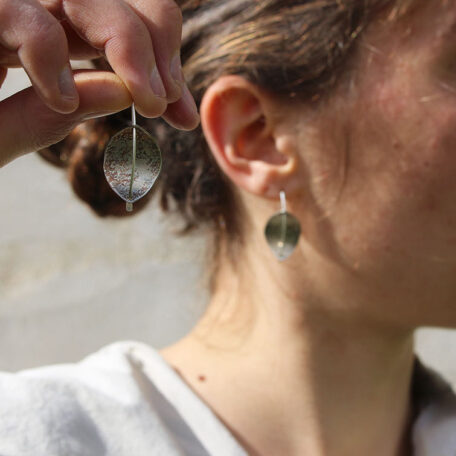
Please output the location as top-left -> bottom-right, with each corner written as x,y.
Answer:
0,341 -> 456,456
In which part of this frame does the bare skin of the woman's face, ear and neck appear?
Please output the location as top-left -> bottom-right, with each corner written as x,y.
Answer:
161,0 -> 456,456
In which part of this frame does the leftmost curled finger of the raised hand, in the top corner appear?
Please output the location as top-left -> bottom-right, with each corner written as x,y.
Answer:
0,0 -> 79,113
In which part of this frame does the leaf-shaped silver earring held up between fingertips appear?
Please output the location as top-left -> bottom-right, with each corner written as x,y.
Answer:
103,104 -> 162,212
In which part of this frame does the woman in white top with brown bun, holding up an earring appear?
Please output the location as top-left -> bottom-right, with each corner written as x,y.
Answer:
0,0 -> 456,456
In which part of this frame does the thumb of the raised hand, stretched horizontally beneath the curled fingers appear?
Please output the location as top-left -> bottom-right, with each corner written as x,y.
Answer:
0,70 -> 132,168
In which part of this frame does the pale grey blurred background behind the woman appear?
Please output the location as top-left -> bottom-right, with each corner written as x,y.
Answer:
0,69 -> 456,385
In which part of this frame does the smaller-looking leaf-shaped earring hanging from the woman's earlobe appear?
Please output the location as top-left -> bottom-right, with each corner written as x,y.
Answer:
264,190 -> 301,261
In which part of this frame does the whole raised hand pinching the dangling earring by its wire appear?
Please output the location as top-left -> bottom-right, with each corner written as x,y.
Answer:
0,0 -> 199,166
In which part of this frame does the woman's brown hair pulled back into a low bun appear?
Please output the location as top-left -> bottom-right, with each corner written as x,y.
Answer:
40,0 -> 413,291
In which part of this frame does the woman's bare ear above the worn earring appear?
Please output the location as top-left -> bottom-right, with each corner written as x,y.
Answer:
200,75 -> 298,198
